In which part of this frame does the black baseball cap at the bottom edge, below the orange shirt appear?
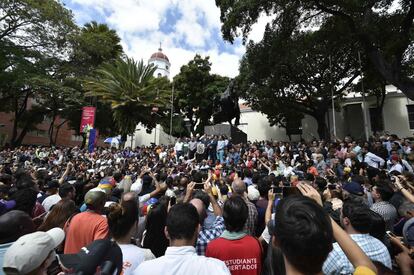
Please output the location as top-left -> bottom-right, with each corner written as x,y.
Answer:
58,239 -> 122,274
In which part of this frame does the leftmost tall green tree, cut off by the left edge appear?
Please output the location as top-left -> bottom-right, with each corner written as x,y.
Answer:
0,0 -> 77,145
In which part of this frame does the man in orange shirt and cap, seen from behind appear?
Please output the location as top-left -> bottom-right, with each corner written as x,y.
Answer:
64,189 -> 109,254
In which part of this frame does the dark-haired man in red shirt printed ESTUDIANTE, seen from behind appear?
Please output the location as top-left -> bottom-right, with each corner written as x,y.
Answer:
206,196 -> 262,275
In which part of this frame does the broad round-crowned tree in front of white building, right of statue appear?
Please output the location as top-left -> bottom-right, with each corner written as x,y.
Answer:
238,22 -> 359,138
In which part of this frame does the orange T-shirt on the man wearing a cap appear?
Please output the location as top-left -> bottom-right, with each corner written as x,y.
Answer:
64,212 -> 109,254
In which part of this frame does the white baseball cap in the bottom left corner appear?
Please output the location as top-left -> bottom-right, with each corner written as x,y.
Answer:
3,227 -> 65,274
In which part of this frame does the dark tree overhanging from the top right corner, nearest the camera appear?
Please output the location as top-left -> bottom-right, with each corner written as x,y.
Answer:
216,0 -> 414,99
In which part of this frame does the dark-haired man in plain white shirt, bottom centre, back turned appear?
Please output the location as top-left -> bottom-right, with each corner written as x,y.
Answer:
134,203 -> 230,275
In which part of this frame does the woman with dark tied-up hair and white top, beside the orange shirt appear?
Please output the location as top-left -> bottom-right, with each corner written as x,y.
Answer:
107,201 -> 155,275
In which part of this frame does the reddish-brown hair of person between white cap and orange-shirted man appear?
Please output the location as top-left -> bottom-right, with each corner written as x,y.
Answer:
38,199 -> 79,231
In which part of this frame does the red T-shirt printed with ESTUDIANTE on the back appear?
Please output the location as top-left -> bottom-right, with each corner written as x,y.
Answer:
206,235 -> 262,275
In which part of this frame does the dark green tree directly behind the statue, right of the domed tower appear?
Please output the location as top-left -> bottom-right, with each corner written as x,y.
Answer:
174,54 -> 229,134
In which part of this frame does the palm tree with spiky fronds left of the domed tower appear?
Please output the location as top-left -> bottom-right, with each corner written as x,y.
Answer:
85,57 -> 170,137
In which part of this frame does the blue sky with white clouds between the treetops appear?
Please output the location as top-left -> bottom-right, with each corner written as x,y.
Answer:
63,0 -> 269,77
